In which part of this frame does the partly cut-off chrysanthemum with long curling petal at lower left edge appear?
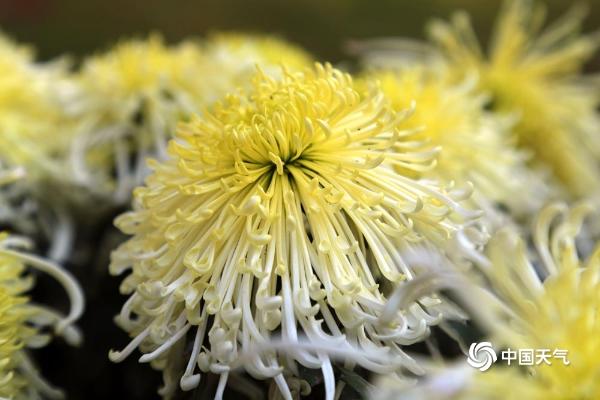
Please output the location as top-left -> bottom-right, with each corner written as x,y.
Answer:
0,233 -> 83,399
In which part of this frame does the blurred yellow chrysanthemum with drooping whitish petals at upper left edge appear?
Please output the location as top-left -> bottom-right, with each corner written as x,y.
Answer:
0,36 -> 86,258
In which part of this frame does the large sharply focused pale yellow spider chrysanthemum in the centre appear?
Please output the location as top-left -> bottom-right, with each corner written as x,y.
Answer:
111,64 -> 474,399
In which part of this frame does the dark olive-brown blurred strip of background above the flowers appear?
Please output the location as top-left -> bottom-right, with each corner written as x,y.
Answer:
0,0 -> 600,62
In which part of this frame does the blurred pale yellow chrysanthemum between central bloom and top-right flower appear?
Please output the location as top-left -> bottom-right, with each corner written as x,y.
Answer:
358,63 -> 548,220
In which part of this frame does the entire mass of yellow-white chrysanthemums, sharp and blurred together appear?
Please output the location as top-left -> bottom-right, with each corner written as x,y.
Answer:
0,0 -> 600,400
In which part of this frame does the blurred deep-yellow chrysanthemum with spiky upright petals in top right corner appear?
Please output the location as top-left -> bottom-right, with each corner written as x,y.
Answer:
431,0 -> 600,197
